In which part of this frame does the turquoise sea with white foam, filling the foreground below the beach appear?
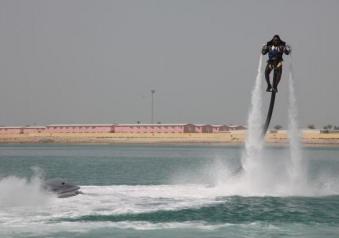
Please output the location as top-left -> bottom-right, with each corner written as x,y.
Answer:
0,145 -> 339,237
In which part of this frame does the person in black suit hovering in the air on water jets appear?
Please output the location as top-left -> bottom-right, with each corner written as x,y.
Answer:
261,35 -> 291,92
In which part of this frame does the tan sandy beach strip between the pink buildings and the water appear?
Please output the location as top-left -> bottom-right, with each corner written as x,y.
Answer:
0,130 -> 339,147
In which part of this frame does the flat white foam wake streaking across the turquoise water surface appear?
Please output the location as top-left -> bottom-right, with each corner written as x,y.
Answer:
0,182 -> 333,235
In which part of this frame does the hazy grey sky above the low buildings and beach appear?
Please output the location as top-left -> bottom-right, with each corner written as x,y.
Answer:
0,0 -> 339,127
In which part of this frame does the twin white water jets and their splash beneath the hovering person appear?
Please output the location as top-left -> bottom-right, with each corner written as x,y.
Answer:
231,57 -> 309,194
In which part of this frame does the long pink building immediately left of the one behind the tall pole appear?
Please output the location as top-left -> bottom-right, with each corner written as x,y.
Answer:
46,124 -> 114,133
